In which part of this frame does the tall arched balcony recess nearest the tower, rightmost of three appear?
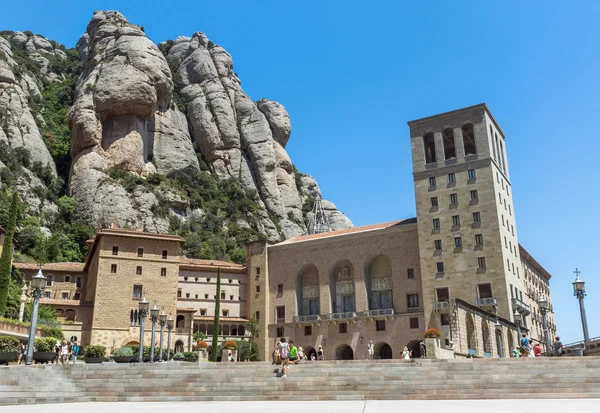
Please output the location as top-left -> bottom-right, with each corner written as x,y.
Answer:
365,254 -> 393,310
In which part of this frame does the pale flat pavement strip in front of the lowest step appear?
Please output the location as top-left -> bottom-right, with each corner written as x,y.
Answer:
2,399 -> 600,413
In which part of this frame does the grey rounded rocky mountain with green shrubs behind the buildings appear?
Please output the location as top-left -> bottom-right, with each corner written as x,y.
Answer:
0,11 -> 352,258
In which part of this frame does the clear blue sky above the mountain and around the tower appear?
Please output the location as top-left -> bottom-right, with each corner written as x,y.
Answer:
0,0 -> 600,343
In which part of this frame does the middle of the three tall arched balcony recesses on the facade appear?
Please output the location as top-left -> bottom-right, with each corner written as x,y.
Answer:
329,258 -> 356,313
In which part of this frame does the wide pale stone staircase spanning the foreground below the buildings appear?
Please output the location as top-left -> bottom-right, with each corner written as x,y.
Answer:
0,357 -> 600,405
